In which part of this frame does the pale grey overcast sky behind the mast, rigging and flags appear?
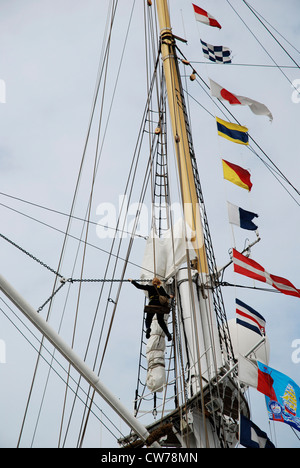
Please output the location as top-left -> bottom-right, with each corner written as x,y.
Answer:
0,0 -> 300,447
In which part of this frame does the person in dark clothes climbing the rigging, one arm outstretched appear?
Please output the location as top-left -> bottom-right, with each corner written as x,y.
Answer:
128,278 -> 174,341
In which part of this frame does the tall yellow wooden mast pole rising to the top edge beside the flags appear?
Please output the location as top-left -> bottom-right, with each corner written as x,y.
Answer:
156,0 -> 208,273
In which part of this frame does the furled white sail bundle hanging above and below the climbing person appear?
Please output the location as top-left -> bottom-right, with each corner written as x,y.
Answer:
141,219 -> 195,393
